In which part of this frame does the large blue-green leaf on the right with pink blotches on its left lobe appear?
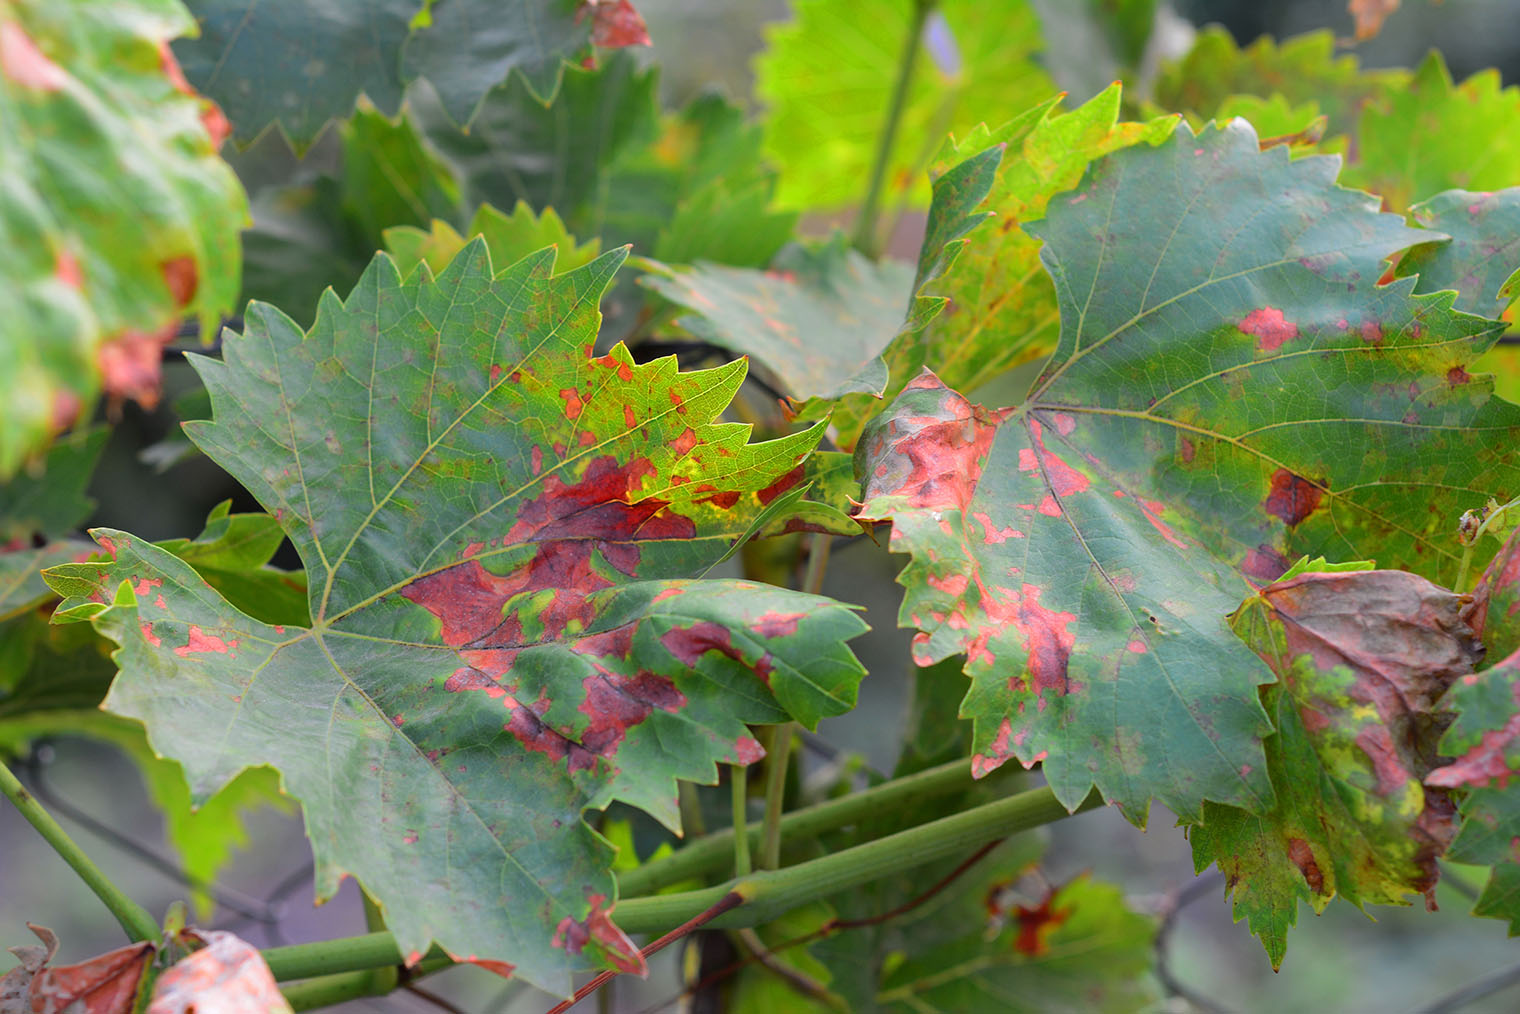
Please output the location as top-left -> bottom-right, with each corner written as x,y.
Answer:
856,120 -> 1520,821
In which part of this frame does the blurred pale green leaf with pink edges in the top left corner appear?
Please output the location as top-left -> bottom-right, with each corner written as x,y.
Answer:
0,0 -> 248,479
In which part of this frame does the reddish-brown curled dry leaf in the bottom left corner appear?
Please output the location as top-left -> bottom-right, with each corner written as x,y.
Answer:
0,923 -> 152,1014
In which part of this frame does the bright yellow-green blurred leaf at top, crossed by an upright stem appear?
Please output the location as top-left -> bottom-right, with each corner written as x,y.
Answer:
755,0 -> 1056,210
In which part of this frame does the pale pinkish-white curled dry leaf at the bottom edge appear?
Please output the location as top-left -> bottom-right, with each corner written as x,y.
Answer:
147,929 -> 290,1014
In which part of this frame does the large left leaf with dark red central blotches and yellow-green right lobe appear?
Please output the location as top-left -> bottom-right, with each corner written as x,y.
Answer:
49,239 -> 865,994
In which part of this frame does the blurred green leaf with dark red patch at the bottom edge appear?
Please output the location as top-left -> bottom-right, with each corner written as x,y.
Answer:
876,876 -> 1160,1014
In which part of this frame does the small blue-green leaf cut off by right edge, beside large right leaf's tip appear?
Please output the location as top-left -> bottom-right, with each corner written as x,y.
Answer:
1398,187 -> 1520,319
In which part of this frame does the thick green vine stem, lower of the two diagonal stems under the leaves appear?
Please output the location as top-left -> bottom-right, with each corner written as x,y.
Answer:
263,784 -> 1102,982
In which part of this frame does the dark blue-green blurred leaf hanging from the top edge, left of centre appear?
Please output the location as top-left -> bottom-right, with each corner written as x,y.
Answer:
175,0 -> 648,152
